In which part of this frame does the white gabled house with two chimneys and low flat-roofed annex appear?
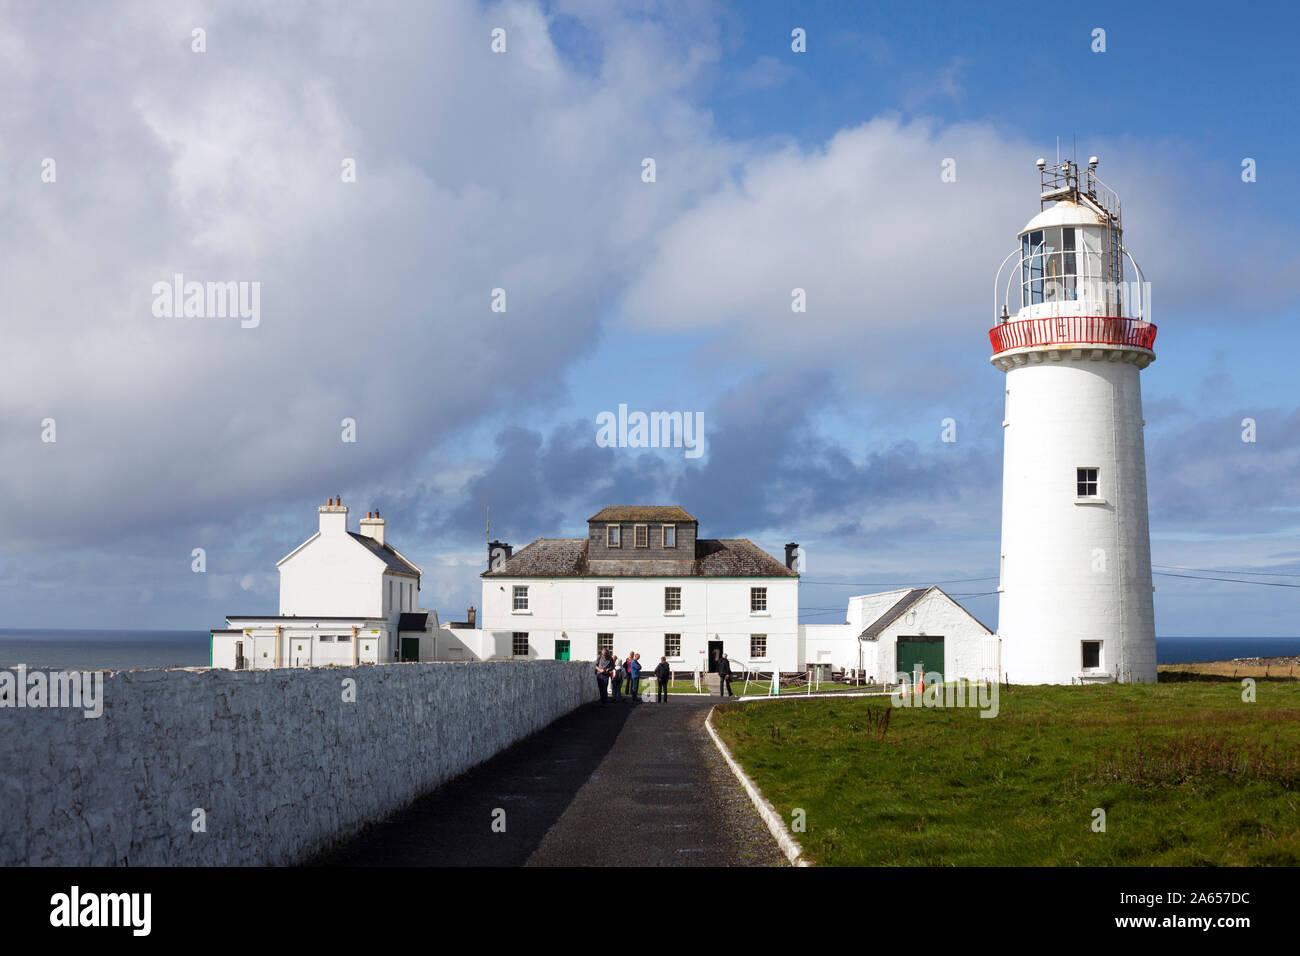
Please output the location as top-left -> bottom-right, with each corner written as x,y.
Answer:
212,498 -> 439,670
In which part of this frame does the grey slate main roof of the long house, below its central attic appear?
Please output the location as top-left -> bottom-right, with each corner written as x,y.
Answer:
481,538 -> 798,578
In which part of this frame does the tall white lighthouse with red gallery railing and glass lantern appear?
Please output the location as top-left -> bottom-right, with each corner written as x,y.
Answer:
989,156 -> 1156,684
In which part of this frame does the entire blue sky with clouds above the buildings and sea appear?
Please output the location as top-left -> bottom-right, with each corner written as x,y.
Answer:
0,0 -> 1300,635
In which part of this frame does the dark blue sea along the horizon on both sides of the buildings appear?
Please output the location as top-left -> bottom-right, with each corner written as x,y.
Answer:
0,628 -> 1300,670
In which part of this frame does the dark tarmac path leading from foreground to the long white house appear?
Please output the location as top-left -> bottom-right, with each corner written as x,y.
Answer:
311,696 -> 785,866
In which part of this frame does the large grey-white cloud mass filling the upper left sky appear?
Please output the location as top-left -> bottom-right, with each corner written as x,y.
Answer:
0,3 -> 731,548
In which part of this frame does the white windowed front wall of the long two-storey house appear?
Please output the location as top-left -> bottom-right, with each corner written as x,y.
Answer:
481,578 -> 802,672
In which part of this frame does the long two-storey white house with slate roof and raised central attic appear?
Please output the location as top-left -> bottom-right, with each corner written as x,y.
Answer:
478,506 -> 802,671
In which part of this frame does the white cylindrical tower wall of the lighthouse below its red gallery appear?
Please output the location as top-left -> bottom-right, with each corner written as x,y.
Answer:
997,349 -> 1156,684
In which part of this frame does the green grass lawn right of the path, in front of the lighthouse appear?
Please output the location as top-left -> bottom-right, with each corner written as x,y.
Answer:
714,680 -> 1300,866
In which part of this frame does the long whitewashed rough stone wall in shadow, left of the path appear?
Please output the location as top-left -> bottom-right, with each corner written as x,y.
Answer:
0,661 -> 597,866
